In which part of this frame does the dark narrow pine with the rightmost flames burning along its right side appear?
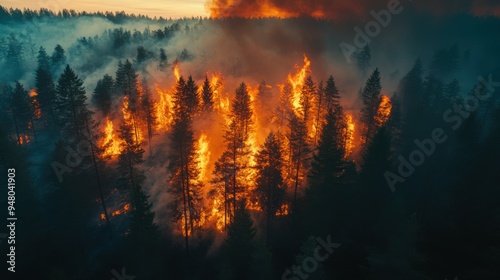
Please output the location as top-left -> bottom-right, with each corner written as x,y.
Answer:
361,68 -> 382,143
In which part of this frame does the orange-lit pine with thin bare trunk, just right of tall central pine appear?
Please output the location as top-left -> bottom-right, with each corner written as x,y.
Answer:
255,132 -> 286,240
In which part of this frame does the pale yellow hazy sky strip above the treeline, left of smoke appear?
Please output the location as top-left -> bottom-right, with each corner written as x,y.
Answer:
0,0 -> 209,18
